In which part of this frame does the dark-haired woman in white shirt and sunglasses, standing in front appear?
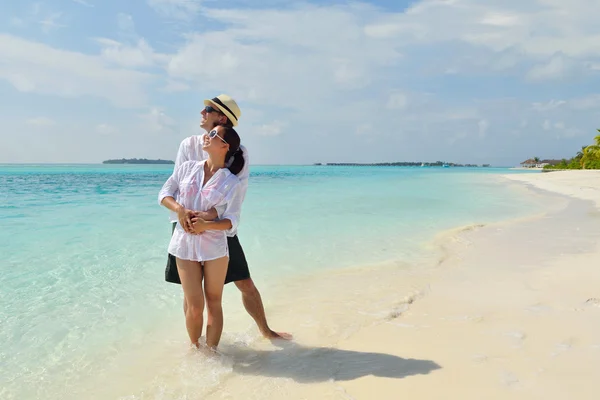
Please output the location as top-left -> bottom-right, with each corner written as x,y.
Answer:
158,126 -> 244,350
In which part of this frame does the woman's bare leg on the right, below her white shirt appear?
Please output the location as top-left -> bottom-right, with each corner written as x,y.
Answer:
204,257 -> 229,349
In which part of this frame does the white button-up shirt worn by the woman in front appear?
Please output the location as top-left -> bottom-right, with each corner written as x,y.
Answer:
158,160 -> 242,261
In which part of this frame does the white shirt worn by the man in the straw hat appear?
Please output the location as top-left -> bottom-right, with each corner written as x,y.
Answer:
169,134 -> 250,236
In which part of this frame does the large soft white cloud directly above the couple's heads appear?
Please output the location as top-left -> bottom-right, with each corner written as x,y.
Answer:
168,5 -> 399,110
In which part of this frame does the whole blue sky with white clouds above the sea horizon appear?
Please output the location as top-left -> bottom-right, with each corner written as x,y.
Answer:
0,0 -> 600,166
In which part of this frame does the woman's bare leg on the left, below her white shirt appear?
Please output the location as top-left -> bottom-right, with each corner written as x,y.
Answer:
177,258 -> 204,347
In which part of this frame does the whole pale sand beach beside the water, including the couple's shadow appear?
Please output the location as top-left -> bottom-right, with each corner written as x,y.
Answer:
200,171 -> 600,400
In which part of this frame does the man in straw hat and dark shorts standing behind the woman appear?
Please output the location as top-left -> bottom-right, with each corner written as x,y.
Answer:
165,94 -> 292,339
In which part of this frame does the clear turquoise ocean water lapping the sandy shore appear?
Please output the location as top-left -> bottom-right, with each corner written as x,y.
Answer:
0,165 -> 544,400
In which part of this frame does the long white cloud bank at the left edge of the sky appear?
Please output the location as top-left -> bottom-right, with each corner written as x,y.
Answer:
0,34 -> 152,107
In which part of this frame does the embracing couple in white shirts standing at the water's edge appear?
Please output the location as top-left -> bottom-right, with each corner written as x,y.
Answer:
158,94 -> 291,350
